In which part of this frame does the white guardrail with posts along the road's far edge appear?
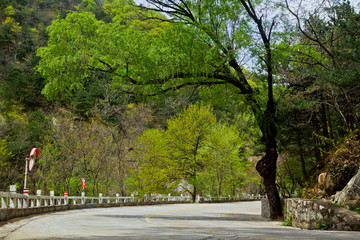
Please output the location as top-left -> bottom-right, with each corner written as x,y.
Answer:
0,192 -> 265,209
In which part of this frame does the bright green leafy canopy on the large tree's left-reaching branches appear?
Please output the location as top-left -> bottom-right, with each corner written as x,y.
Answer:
37,0 -> 236,100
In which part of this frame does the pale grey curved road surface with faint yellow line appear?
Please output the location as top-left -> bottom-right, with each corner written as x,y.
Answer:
0,202 -> 360,240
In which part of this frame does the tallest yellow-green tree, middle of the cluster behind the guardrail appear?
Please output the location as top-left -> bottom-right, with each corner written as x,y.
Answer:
165,105 -> 216,199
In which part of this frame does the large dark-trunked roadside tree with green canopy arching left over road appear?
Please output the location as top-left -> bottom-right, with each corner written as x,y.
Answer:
38,0 -> 282,218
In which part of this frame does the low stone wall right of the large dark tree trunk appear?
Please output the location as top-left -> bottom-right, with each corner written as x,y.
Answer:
285,199 -> 360,231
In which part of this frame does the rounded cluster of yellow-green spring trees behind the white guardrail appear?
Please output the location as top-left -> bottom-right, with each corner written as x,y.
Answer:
135,104 -> 247,196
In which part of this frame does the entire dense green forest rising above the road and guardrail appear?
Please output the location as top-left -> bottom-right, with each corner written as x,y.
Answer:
0,0 -> 360,218
